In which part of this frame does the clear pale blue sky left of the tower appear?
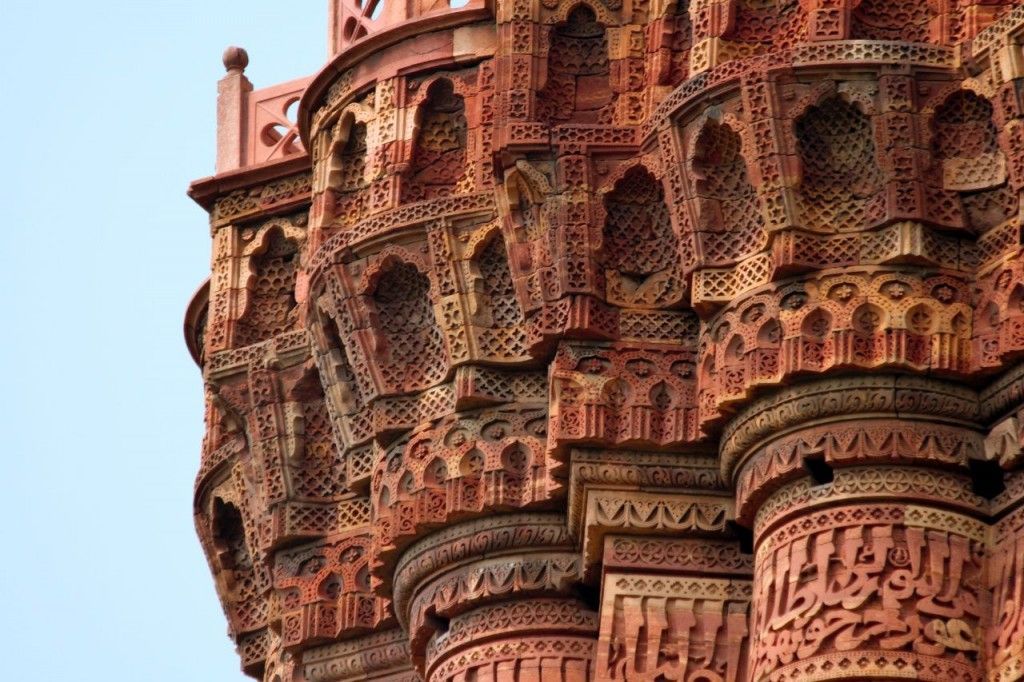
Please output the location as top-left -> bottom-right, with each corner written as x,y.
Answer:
0,0 -> 327,682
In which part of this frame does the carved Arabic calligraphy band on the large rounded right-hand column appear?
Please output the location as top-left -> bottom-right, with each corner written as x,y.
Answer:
751,499 -> 988,680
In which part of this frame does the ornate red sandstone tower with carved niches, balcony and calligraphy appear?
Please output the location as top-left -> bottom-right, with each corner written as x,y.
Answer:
185,0 -> 1024,682
